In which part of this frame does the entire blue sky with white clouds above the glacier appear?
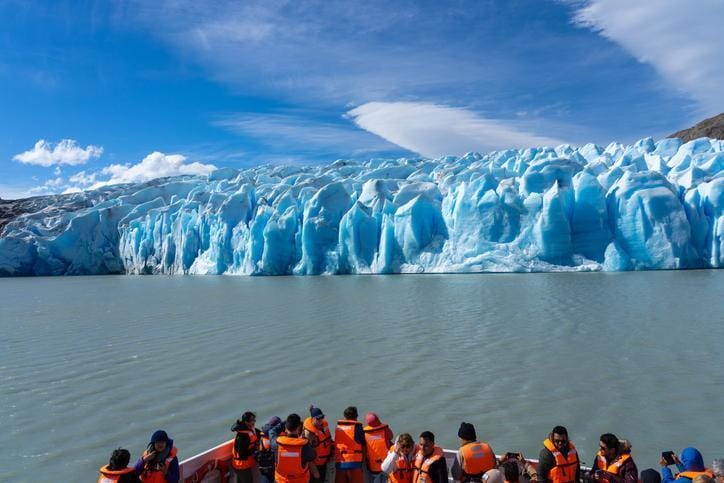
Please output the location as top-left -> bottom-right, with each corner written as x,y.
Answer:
0,0 -> 724,198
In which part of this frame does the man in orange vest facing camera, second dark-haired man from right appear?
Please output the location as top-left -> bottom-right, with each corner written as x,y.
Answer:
538,426 -> 581,483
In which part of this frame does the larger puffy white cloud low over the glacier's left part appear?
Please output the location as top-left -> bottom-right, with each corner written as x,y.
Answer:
92,151 -> 216,188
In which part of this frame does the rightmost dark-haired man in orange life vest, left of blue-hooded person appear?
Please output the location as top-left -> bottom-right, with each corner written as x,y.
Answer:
588,433 -> 639,483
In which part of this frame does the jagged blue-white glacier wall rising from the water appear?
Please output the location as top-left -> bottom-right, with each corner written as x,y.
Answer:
0,138 -> 724,276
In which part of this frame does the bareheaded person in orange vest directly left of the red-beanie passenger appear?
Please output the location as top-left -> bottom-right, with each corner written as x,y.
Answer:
334,406 -> 365,483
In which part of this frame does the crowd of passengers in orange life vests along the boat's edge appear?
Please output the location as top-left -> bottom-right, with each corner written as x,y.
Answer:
98,406 -> 724,483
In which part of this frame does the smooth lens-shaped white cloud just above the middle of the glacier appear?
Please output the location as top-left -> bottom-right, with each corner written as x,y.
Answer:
347,102 -> 562,157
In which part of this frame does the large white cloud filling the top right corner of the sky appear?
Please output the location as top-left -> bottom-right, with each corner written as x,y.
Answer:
574,0 -> 724,114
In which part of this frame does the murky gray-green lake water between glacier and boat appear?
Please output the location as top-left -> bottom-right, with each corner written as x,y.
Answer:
0,271 -> 724,482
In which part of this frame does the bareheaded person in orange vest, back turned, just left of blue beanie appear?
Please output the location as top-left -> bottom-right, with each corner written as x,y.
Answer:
271,414 -> 319,483
